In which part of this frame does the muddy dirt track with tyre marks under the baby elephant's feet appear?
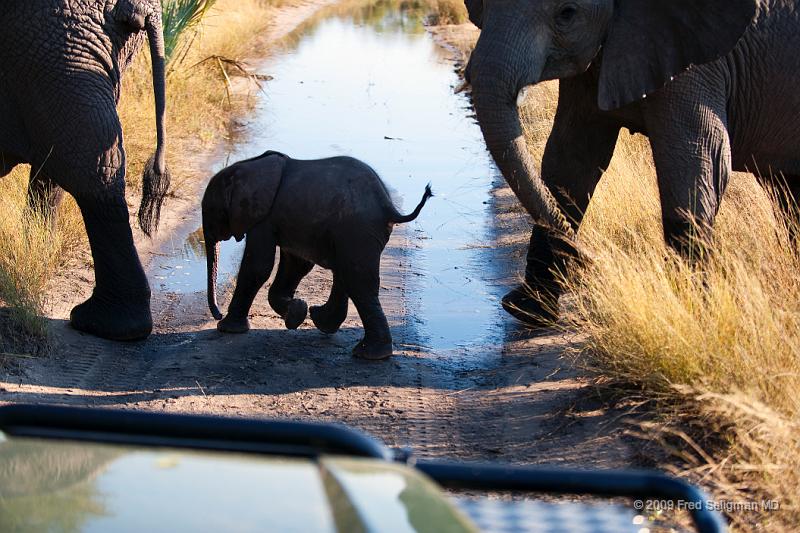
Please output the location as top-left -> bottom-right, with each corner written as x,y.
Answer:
0,4 -> 641,467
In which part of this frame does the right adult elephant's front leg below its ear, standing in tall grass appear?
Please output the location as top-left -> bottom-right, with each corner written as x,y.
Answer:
644,68 -> 731,260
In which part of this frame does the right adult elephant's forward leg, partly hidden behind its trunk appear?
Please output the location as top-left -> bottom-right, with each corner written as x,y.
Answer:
502,78 -> 620,327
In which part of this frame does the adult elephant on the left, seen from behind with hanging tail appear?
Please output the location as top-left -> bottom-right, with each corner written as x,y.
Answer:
0,0 -> 169,340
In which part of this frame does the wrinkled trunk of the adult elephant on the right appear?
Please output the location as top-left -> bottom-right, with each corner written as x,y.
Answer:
467,42 -> 575,240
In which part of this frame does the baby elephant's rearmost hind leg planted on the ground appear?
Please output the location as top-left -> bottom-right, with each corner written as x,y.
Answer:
334,234 -> 392,360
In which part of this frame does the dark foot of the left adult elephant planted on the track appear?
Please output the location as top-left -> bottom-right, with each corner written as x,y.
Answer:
69,295 -> 153,341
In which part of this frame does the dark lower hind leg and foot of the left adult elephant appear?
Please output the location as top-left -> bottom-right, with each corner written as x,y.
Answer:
70,191 -> 153,341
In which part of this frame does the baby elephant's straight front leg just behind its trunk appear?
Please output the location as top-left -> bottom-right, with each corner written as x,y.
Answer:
217,223 -> 277,333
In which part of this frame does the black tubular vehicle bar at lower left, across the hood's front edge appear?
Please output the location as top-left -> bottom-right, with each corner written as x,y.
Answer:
0,405 -> 392,461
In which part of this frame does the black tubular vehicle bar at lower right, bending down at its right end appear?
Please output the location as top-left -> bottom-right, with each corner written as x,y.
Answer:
414,460 -> 727,533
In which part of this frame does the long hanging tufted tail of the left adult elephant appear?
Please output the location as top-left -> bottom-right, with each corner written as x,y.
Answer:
139,9 -> 170,237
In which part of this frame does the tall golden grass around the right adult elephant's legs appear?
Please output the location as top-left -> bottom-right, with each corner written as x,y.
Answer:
523,84 -> 800,531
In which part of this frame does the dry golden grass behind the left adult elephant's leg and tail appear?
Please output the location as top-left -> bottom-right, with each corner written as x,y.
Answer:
0,0 -> 288,344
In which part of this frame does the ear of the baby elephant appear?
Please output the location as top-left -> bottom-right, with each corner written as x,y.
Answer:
227,153 -> 286,241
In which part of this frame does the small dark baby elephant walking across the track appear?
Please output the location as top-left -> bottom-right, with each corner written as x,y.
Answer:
203,151 -> 433,359
